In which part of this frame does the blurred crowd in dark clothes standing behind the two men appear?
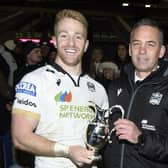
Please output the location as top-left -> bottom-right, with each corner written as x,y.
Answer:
0,30 -> 167,168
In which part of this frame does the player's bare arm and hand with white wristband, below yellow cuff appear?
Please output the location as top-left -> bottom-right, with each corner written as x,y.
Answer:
12,114 -> 93,166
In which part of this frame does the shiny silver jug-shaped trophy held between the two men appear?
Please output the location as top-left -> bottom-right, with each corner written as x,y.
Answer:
86,102 -> 124,161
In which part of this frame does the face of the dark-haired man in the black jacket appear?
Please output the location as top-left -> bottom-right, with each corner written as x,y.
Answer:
129,25 -> 165,78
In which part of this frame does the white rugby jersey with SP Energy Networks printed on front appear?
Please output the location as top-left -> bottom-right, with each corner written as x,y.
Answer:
13,65 -> 108,168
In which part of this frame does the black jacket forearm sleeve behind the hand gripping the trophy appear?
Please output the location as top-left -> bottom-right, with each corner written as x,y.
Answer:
135,130 -> 168,163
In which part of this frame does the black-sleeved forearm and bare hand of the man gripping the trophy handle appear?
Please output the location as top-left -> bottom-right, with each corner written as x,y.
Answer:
114,119 -> 168,163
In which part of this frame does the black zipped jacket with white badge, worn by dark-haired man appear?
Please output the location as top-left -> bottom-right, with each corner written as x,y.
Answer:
103,61 -> 168,168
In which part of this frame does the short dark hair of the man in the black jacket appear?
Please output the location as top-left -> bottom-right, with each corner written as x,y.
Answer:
130,18 -> 164,44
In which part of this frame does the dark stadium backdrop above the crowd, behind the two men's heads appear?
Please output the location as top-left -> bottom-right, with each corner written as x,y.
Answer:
0,0 -> 168,60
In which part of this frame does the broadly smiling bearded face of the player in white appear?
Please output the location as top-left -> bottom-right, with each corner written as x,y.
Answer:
55,18 -> 88,67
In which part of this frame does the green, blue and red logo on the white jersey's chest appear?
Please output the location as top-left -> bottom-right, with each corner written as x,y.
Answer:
55,91 -> 72,102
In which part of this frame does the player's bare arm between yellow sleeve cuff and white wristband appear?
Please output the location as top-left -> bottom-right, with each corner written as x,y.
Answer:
12,114 -> 54,156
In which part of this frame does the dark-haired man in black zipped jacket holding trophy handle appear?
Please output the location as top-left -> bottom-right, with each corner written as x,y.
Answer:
103,19 -> 168,168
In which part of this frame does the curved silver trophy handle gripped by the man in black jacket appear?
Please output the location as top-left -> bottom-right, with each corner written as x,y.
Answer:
107,104 -> 125,143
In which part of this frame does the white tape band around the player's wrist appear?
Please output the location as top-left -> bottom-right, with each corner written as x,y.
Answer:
54,143 -> 69,157
